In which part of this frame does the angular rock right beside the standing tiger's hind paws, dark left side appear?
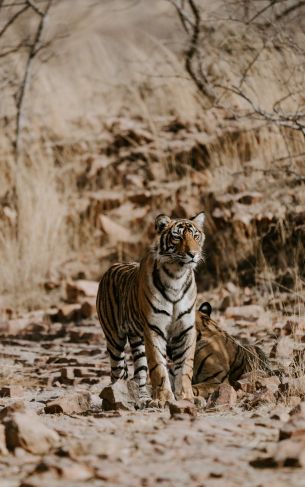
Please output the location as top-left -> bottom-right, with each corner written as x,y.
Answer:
100,380 -> 136,411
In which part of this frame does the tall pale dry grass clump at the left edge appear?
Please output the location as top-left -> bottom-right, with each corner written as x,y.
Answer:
0,152 -> 67,305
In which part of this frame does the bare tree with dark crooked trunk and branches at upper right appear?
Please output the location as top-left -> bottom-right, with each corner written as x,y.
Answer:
169,0 -> 305,136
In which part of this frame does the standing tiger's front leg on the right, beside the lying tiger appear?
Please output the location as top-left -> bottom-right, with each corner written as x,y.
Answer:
171,320 -> 196,402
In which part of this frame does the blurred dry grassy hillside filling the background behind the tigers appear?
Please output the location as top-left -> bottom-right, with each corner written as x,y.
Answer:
0,0 -> 304,305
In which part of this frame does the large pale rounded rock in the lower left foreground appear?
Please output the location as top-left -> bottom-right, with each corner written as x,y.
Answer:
3,412 -> 59,455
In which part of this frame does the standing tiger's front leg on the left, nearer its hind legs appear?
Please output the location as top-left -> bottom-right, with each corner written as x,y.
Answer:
145,328 -> 175,406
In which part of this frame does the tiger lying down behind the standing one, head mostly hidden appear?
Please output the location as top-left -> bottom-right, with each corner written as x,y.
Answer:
192,302 -> 274,398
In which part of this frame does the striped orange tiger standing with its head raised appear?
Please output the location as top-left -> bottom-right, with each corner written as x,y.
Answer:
97,213 -> 205,404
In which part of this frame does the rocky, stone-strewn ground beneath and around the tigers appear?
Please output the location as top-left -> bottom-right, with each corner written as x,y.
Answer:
0,281 -> 305,487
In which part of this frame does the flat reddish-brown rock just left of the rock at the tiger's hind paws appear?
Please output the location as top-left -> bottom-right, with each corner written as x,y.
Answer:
44,392 -> 91,414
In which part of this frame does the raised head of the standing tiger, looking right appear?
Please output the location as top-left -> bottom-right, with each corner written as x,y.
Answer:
155,213 -> 205,267
